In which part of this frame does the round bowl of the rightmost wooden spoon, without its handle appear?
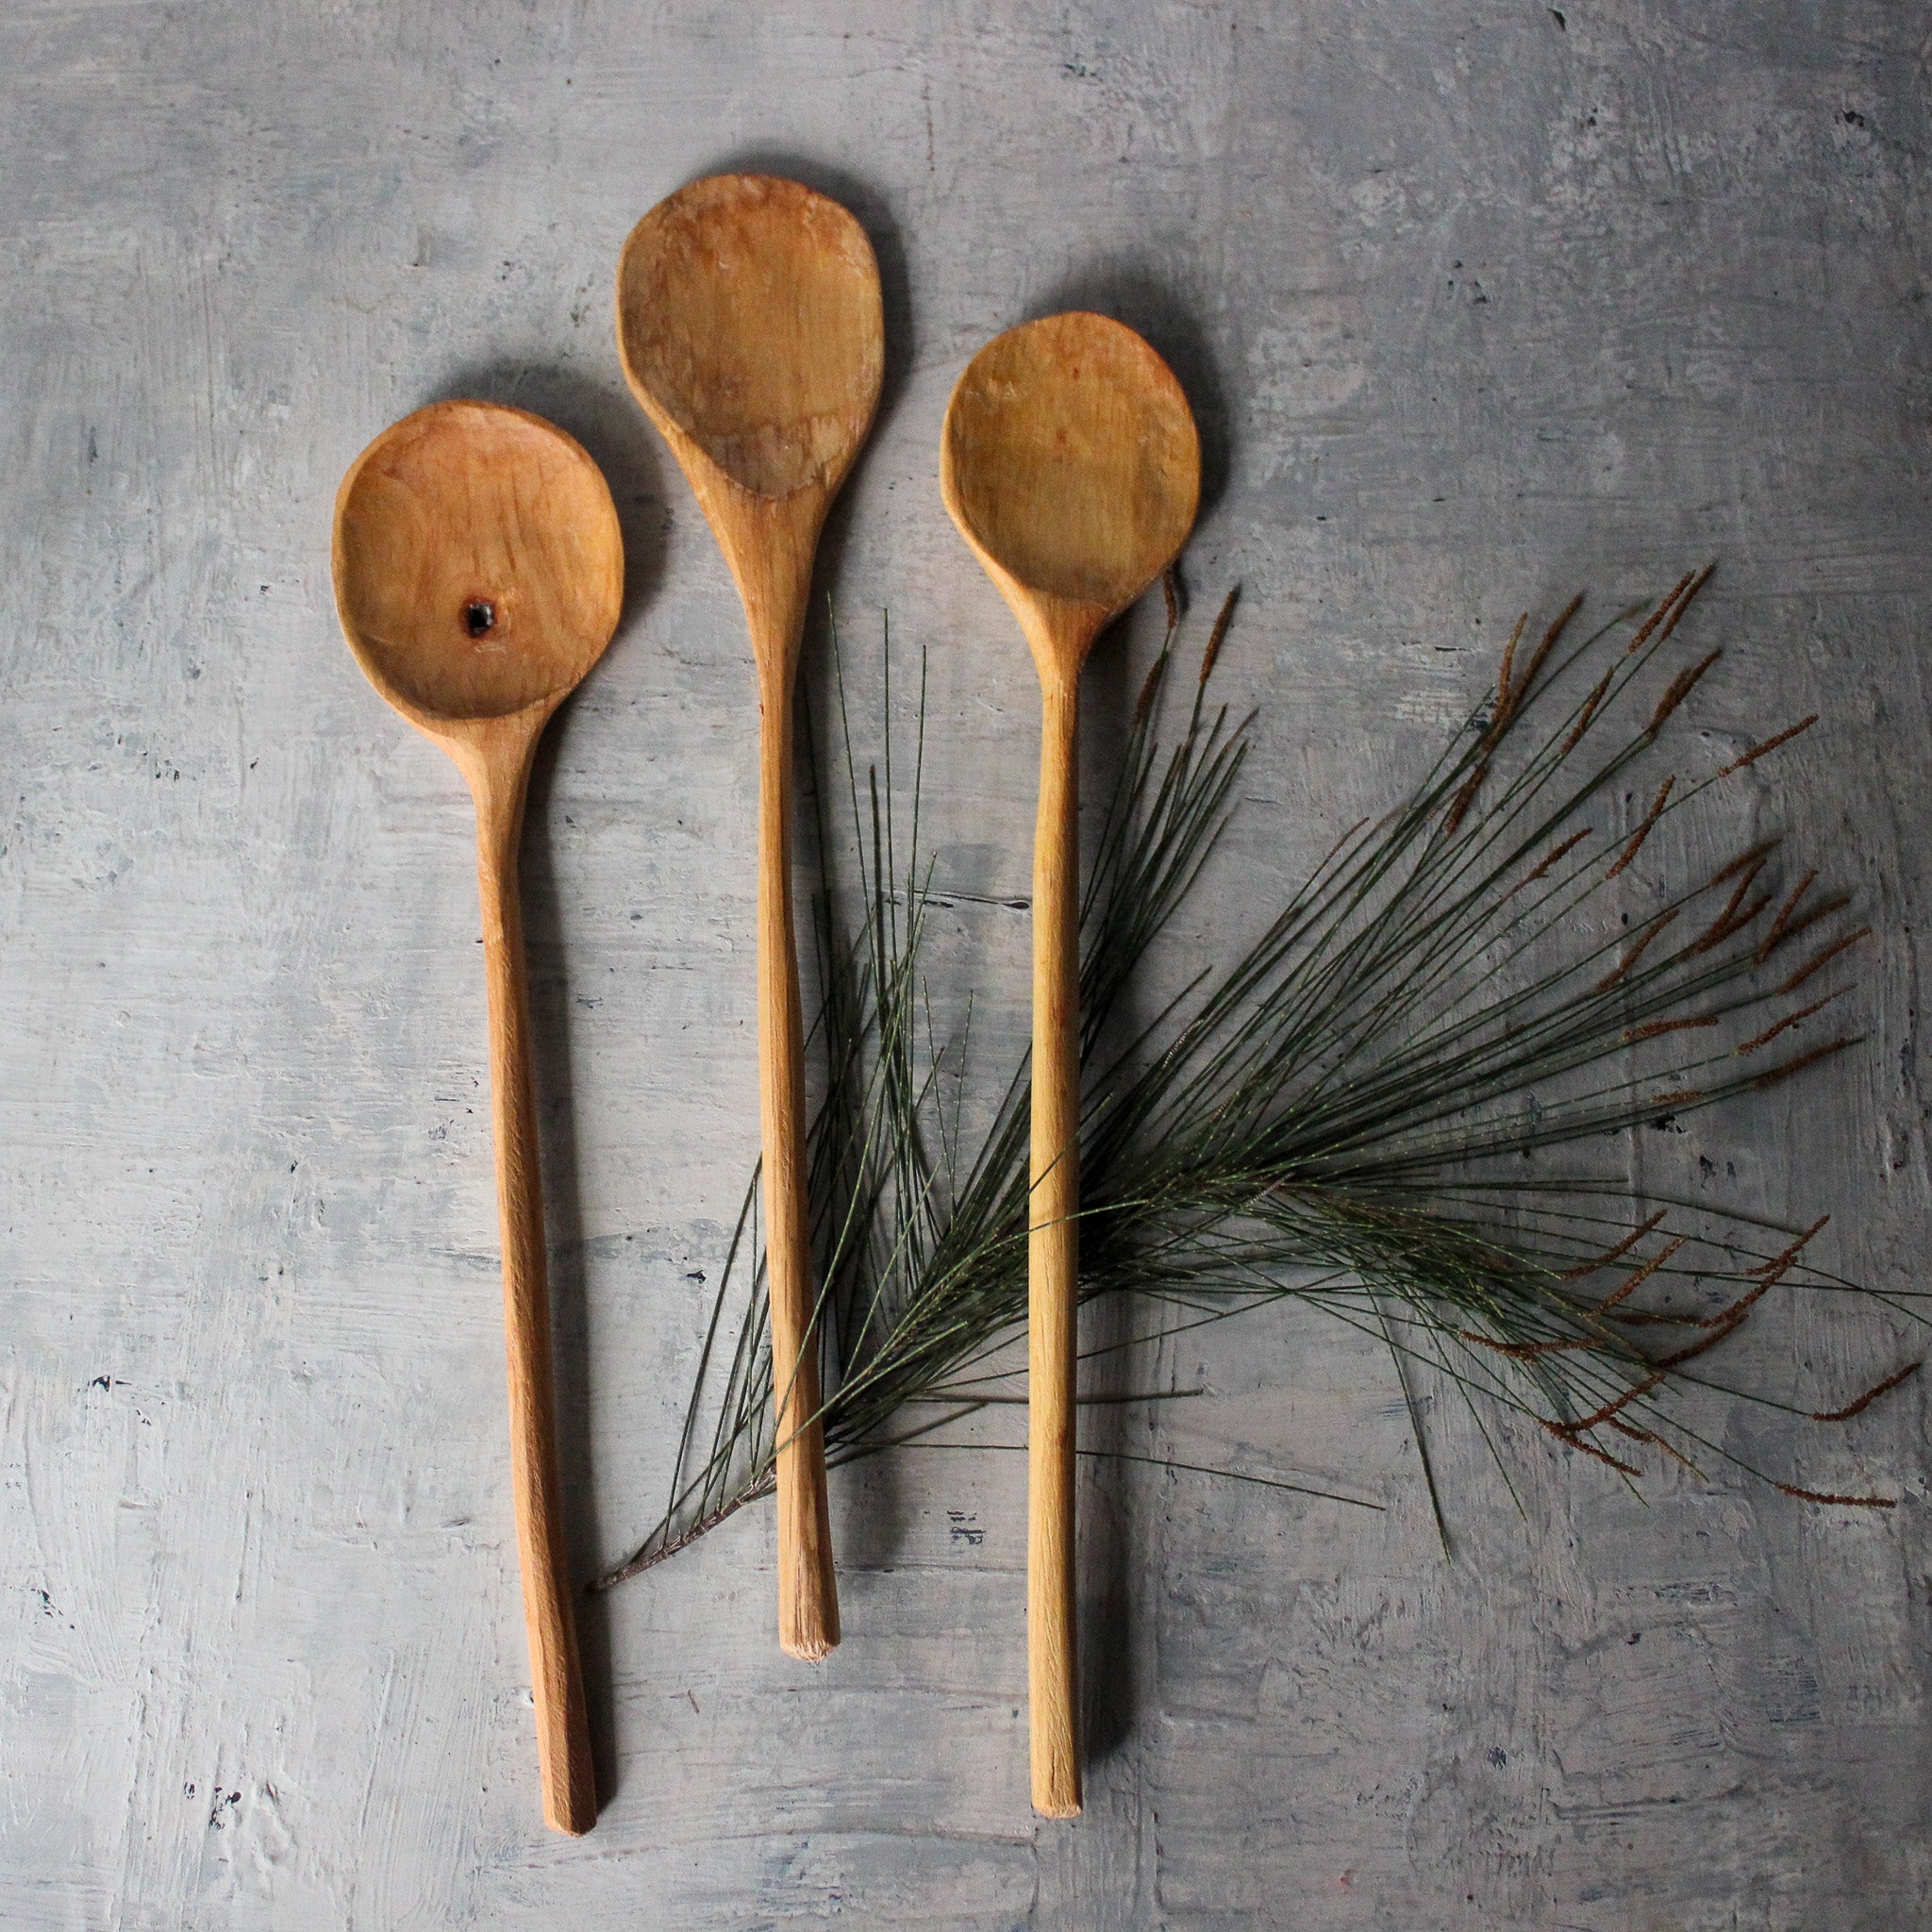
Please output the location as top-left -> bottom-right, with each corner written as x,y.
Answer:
939,311 -> 1200,612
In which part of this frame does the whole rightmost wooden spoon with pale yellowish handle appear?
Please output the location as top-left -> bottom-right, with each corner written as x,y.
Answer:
939,313 -> 1200,1818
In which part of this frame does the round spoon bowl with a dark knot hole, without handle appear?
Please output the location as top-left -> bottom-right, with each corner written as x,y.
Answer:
334,402 -> 625,728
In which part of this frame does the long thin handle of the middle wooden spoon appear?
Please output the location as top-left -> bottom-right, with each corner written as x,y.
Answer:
758,662 -> 839,1661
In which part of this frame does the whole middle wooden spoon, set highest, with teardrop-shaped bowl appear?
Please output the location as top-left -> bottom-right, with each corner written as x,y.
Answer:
616,174 -> 885,1657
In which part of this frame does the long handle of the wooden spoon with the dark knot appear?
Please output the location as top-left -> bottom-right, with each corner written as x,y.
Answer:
474,754 -> 597,1834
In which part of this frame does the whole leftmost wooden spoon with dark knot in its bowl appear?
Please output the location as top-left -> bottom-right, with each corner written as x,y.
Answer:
334,402 -> 625,1832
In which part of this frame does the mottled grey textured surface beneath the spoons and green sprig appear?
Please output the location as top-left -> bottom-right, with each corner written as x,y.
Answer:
0,0 -> 1932,1932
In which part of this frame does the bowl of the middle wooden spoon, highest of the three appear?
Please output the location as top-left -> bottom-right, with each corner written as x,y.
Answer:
616,174 -> 885,496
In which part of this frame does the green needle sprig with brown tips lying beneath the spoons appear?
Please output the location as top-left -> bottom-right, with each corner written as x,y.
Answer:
599,570 -> 1921,1588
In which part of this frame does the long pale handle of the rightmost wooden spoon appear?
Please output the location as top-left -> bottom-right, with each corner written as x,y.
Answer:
1025,669 -> 1080,1818
